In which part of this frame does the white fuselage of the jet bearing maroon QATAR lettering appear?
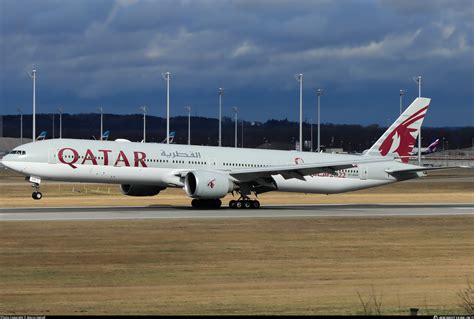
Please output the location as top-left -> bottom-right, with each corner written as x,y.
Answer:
2,139 -> 420,194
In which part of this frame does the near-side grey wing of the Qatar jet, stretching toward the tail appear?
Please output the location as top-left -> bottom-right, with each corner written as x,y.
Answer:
229,158 -> 391,182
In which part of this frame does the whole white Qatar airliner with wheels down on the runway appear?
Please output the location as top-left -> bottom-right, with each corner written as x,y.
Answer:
2,98 -> 466,209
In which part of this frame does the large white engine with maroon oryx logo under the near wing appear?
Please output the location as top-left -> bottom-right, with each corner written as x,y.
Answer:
184,171 -> 235,199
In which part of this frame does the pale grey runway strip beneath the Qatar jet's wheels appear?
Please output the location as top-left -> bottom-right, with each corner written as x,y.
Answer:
0,204 -> 474,221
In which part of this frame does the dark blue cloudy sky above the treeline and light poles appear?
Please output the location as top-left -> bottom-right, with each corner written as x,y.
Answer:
0,0 -> 474,127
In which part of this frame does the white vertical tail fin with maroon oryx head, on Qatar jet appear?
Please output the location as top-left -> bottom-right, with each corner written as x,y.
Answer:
366,97 -> 431,163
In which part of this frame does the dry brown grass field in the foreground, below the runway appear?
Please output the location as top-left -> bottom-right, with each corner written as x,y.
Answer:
0,217 -> 474,314
